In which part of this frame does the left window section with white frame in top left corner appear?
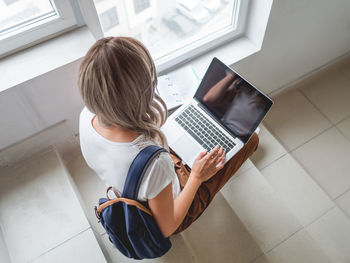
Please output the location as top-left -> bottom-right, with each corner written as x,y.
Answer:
0,0 -> 77,56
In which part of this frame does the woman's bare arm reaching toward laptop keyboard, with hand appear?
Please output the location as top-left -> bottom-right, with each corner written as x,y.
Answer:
148,147 -> 225,237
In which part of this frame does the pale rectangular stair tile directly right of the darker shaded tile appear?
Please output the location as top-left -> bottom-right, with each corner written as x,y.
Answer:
221,168 -> 302,252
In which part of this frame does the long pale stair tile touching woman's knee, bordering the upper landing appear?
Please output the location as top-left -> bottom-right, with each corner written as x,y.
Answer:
251,126 -> 335,226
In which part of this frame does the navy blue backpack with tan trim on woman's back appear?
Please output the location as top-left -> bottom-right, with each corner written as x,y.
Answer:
95,145 -> 171,259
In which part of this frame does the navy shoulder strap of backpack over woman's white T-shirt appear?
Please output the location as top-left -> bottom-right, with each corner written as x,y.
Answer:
122,145 -> 166,200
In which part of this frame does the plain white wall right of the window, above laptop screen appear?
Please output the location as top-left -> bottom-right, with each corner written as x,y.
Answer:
232,0 -> 350,93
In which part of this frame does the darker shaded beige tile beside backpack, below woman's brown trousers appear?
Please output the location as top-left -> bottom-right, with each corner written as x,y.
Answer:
183,193 -> 262,263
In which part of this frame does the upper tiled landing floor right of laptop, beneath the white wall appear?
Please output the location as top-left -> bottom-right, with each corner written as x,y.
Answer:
265,57 -> 350,202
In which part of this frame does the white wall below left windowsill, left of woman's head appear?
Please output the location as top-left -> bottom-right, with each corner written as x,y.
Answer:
0,60 -> 84,166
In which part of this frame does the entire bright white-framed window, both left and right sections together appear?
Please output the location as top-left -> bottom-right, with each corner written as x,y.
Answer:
0,0 -> 249,71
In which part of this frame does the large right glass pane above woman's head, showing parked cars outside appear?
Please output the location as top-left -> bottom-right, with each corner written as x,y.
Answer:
94,0 -> 237,59
